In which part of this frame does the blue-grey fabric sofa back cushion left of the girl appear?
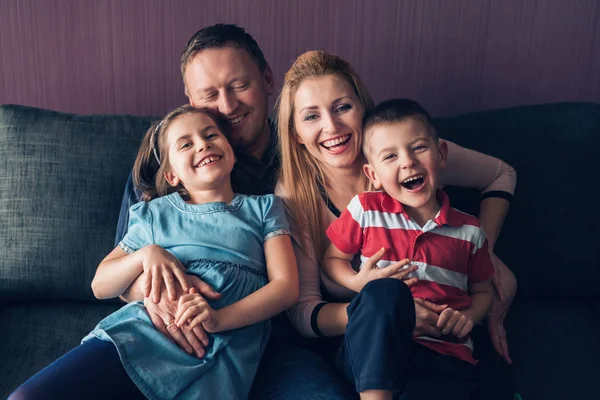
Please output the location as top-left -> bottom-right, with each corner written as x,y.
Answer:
0,105 -> 152,299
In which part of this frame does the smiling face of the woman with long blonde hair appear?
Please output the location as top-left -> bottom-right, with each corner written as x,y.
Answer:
293,75 -> 364,168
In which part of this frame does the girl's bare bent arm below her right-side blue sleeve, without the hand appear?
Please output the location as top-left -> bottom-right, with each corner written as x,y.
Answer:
205,235 -> 298,332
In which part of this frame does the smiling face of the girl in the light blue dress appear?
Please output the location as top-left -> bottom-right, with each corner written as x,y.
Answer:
164,113 -> 235,194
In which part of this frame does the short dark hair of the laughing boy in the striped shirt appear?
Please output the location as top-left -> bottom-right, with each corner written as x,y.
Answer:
363,99 -> 439,156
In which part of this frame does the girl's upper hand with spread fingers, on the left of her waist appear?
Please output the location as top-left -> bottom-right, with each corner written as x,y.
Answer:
141,244 -> 190,303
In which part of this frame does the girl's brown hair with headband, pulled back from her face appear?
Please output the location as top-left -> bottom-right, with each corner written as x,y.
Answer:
132,105 -> 229,201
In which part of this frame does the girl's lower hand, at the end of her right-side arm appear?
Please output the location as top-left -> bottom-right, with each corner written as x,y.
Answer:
175,288 -> 219,332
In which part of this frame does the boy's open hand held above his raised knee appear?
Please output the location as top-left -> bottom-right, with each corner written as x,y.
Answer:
353,247 -> 418,292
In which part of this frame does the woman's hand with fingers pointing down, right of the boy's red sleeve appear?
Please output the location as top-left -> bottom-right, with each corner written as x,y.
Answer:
487,253 -> 517,364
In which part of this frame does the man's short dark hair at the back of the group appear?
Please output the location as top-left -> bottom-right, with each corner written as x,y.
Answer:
180,24 -> 267,76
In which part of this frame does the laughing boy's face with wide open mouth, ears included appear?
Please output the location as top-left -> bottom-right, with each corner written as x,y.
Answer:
364,118 -> 448,208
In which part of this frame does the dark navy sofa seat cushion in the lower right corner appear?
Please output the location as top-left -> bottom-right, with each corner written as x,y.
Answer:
507,298 -> 600,400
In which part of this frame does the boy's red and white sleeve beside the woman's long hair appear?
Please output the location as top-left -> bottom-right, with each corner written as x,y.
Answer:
327,195 -> 365,254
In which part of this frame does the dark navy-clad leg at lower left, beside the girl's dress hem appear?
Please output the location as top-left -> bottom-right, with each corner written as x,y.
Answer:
9,339 -> 144,400
